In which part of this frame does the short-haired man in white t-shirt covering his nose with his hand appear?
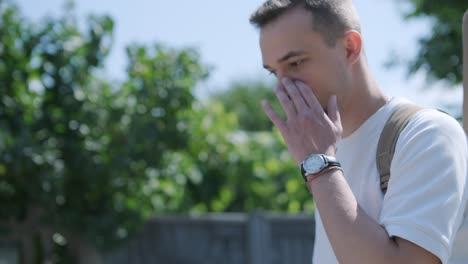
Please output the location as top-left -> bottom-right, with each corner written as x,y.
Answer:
250,0 -> 468,264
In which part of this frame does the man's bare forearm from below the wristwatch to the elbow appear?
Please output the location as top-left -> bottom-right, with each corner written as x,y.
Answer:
309,170 -> 441,264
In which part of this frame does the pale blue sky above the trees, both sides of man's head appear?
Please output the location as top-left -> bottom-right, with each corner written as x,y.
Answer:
13,0 -> 461,108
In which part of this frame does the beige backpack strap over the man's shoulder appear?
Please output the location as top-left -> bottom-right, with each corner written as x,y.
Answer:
376,104 -> 423,194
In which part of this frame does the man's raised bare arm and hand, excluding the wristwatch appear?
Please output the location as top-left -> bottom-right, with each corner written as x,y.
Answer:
264,79 -> 441,264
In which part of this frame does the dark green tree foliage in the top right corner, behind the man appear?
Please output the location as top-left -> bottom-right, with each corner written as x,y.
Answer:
398,0 -> 468,84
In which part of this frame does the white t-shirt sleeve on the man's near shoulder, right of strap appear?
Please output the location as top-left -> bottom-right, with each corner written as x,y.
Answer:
380,110 -> 468,263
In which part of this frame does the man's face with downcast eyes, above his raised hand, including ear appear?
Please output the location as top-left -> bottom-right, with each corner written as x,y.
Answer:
260,8 -> 350,109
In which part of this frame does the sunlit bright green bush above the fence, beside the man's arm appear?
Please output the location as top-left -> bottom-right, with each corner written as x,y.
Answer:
176,99 -> 313,213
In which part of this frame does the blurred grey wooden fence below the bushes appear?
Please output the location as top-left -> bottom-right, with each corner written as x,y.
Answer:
106,213 -> 315,264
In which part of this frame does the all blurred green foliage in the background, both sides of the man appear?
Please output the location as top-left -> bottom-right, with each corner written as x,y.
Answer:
0,0 -> 468,263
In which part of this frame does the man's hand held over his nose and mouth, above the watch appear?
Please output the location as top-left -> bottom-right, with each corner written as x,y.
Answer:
262,78 -> 343,164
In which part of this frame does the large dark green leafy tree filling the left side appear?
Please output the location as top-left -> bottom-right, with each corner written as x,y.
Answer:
0,3 -> 207,263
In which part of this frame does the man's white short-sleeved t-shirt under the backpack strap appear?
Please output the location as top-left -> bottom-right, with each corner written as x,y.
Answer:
313,98 -> 468,264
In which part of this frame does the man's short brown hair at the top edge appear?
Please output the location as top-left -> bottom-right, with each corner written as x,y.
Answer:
250,0 -> 361,46
